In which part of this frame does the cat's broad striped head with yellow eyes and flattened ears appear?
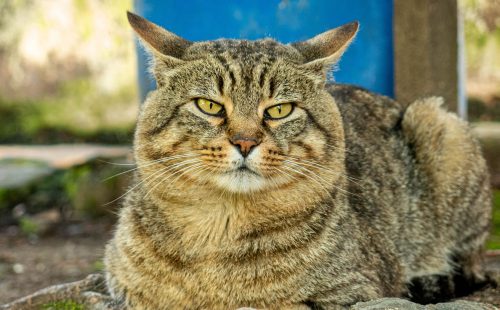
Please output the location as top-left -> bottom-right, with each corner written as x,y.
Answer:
128,13 -> 358,194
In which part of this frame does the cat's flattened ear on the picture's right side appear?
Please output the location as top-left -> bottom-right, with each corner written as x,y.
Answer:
291,21 -> 359,73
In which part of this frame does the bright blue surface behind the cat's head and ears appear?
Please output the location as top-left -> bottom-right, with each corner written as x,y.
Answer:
135,0 -> 394,99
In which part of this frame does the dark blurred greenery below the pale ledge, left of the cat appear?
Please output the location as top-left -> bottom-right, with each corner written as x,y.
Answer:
0,160 -> 130,226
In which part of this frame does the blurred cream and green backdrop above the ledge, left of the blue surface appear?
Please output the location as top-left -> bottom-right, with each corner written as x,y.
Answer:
0,0 -> 138,143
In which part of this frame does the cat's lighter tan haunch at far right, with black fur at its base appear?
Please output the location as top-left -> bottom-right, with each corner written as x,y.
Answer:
402,97 -> 491,299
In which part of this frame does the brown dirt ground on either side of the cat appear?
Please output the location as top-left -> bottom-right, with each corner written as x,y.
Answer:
0,221 -> 500,306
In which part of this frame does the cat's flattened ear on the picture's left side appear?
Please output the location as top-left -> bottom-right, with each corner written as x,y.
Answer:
127,11 -> 192,67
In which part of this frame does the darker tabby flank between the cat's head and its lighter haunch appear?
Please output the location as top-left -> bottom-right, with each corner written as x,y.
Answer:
326,84 -> 410,245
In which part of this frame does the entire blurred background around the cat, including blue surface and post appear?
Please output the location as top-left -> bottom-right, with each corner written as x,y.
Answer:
0,0 -> 500,304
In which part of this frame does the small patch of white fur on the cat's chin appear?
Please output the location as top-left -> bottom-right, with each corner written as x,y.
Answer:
214,171 -> 266,193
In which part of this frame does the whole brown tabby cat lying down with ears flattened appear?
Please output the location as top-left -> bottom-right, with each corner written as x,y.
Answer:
105,13 -> 491,309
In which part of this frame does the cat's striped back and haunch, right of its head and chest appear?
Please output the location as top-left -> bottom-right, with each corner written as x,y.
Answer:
327,85 -> 490,286
